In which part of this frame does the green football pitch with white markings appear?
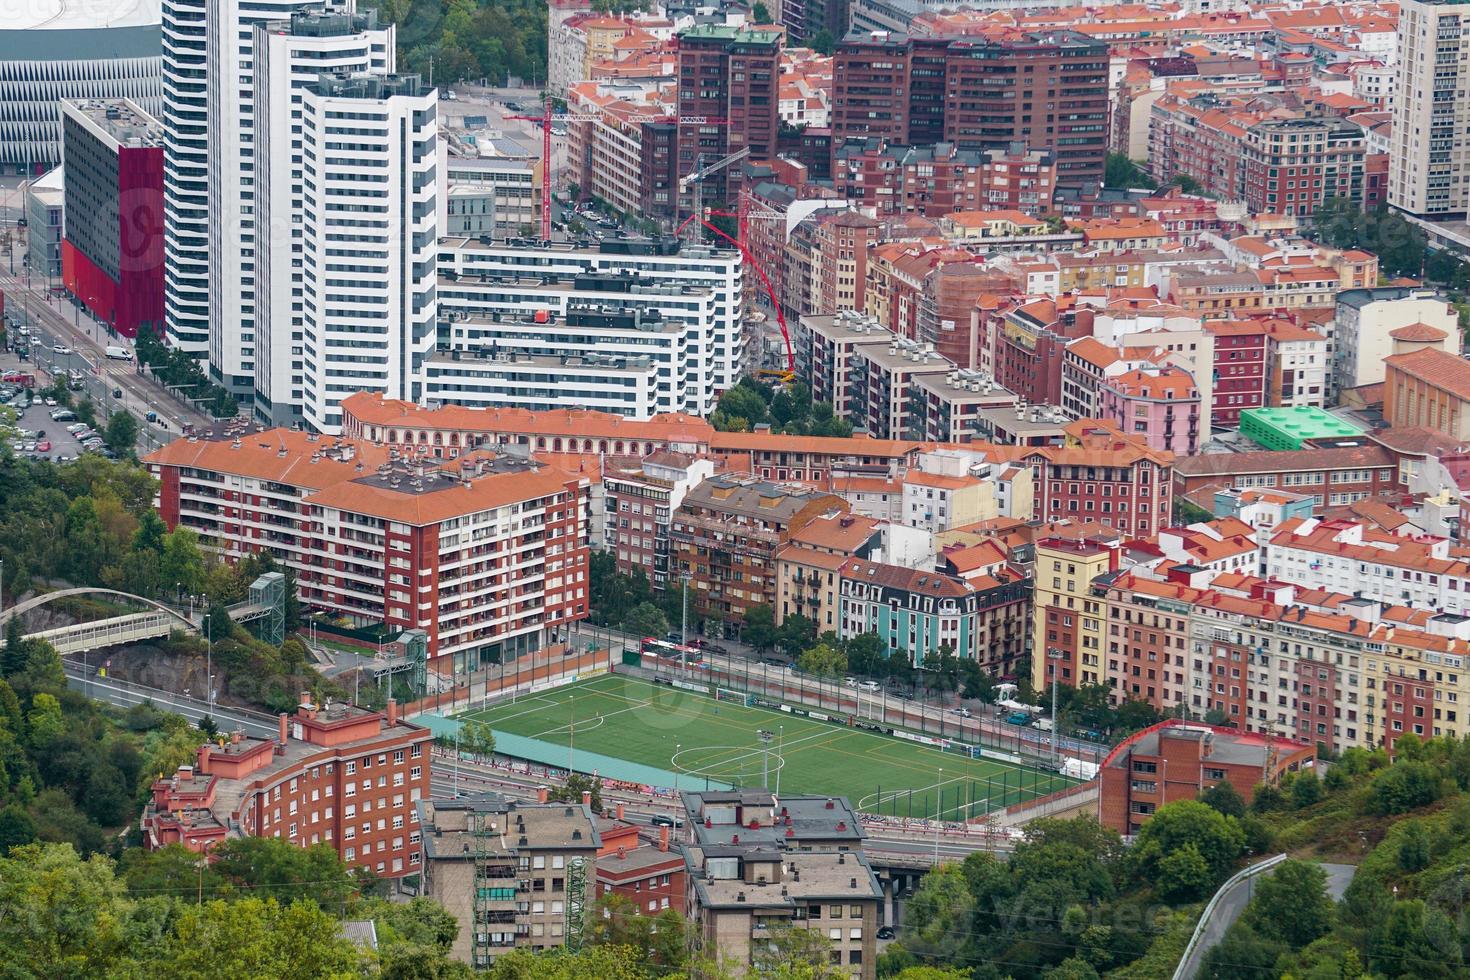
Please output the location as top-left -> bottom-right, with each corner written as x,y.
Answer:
462,674 -> 1072,820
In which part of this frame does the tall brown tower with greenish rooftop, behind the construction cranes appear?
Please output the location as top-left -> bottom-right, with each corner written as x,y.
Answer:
678,24 -> 784,207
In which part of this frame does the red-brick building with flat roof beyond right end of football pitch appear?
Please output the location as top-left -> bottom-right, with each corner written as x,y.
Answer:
1100,720 -> 1317,836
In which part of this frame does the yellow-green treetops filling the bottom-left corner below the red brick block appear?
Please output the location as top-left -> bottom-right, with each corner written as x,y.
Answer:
0,840 -> 473,980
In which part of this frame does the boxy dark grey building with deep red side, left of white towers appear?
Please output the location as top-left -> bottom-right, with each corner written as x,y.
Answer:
60,98 -> 163,336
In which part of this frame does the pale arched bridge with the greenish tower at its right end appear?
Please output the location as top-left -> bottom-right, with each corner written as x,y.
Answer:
0,573 -> 285,657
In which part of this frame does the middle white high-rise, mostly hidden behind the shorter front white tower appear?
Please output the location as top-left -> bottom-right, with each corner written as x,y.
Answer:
252,9 -> 395,425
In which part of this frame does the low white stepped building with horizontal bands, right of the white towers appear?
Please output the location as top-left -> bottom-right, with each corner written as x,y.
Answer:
438,238 -> 735,417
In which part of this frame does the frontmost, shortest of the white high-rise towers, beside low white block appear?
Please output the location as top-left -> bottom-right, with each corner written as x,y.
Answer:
301,75 -> 438,433
